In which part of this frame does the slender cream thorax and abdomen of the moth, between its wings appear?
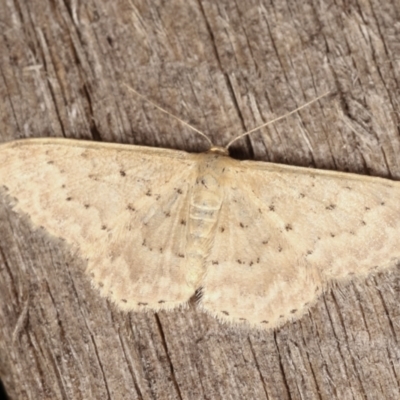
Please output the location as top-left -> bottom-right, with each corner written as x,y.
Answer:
186,152 -> 229,285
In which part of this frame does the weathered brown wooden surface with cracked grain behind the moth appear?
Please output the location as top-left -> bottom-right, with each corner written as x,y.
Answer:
0,0 -> 400,400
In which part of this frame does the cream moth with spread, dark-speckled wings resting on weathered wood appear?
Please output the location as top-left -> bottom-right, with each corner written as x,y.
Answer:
0,92 -> 400,329
